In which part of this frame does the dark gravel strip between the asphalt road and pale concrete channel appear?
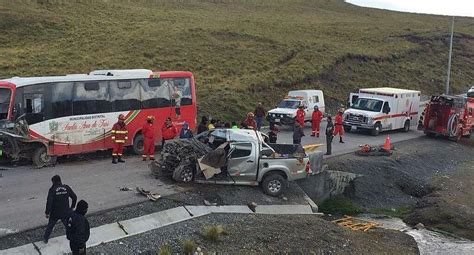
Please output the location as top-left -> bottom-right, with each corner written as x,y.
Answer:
0,183 -> 307,250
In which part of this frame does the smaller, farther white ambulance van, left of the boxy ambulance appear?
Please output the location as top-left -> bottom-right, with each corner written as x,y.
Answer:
267,90 -> 325,125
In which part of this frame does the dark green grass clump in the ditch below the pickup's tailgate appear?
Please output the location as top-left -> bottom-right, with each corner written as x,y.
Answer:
319,195 -> 365,215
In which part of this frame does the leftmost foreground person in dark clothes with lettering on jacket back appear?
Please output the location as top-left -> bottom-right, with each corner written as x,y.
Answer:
43,175 -> 77,243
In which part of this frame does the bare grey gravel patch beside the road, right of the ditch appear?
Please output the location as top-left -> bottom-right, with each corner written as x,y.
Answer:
326,137 -> 474,209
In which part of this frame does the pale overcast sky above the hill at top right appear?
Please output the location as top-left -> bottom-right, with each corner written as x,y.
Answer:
346,0 -> 474,17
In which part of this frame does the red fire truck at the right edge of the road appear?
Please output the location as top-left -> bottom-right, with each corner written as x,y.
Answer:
418,95 -> 474,141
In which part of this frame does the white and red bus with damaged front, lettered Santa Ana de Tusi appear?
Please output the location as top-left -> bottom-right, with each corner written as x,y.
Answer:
0,69 -> 196,166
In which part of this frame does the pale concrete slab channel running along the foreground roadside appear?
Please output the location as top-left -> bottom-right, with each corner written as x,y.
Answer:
0,203 -> 315,255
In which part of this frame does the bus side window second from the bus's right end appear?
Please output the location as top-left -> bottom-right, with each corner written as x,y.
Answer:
140,78 -> 171,109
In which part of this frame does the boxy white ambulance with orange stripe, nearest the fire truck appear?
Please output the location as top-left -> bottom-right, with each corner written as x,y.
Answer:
343,88 -> 421,135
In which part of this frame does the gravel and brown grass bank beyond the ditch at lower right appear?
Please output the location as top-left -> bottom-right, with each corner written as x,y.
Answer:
328,138 -> 474,239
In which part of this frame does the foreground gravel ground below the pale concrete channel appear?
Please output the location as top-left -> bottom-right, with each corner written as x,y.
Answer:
88,214 -> 418,254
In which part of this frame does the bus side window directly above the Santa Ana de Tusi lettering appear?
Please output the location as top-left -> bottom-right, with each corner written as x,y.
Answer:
73,81 -> 112,115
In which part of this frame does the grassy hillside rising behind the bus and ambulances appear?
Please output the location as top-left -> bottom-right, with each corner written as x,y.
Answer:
0,0 -> 474,120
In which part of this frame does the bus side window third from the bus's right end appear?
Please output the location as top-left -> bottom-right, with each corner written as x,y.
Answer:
109,80 -> 141,112
